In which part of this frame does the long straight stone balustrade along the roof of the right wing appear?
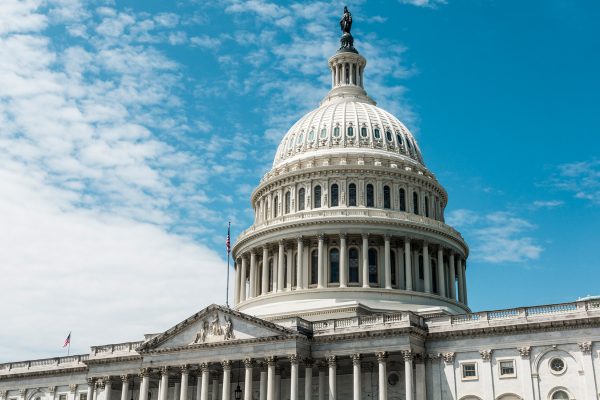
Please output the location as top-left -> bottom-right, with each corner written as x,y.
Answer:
426,299 -> 600,333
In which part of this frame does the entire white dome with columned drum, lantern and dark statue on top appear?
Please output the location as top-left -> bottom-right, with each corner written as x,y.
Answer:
233,8 -> 469,320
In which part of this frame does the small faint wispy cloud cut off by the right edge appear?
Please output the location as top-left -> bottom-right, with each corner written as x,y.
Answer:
549,160 -> 600,206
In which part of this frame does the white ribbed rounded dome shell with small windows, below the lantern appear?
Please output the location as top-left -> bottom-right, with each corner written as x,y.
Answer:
273,101 -> 423,167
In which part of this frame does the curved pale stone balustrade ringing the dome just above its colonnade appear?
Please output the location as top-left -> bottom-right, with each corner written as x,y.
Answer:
234,207 -> 463,241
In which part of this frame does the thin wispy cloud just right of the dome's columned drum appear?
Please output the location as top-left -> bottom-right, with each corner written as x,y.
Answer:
446,209 -> 544,264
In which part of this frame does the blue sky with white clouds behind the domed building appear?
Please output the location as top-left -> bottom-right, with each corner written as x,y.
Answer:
0,0 -> 600,362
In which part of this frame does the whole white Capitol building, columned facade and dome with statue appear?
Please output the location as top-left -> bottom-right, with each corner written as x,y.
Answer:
0,10 -> 600,400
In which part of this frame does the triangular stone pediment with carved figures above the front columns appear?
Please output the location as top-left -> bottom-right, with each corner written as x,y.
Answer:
138,304 -> 298,352
